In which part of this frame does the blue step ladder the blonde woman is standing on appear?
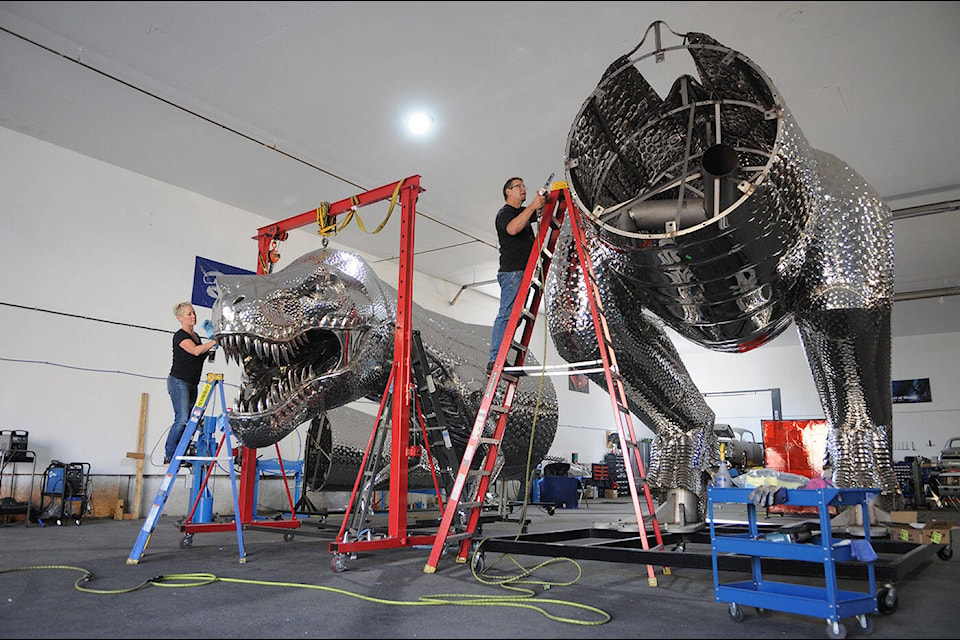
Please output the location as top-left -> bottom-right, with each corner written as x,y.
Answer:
127,373 -> 247,564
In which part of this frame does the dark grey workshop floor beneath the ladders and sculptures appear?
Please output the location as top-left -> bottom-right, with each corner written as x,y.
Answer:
0,498 -> 960,638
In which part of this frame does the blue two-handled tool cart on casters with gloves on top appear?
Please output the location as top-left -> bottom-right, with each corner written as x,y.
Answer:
707,487 -> 880,639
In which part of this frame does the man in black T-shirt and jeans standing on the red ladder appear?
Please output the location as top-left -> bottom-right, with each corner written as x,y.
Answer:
487,174 -> 553,375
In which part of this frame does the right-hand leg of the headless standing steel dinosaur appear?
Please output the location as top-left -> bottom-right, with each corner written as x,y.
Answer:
796,151 -> 903,509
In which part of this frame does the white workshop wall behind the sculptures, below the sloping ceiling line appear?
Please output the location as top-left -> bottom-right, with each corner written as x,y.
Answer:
0,128 -> 960,516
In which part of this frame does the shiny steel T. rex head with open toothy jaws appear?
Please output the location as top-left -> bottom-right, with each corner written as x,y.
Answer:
213,249 -> 396,448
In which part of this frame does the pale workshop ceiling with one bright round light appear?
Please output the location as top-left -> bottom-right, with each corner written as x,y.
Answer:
0,2 -> 960,334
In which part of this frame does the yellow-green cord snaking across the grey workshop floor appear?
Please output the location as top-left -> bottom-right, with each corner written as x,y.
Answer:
0,562 -> 610,626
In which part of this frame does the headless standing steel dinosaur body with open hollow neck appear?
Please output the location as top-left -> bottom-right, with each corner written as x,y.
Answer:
546,22 -> 902,527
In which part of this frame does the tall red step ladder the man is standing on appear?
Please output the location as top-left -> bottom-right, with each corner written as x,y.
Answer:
424,182 -> 670,586
